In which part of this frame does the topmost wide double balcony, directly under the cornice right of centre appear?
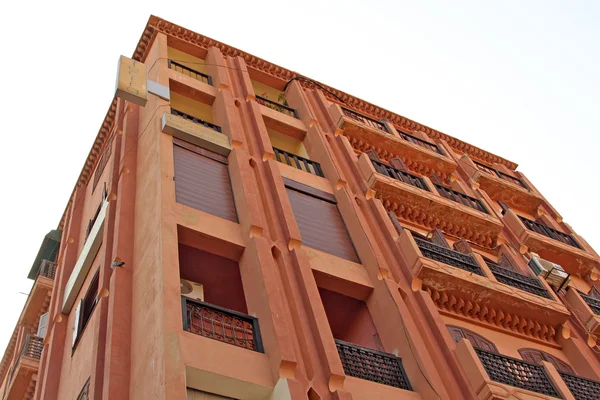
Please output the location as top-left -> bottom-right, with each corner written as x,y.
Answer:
331,105 -> 456,178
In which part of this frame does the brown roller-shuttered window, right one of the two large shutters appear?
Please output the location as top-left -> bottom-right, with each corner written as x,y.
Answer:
286,184 -> 360,262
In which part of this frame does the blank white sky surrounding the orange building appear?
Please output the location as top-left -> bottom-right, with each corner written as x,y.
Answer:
0,0 -> 600,352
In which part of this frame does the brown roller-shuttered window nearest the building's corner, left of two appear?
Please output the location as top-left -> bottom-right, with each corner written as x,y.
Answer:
173,139 -> 238,222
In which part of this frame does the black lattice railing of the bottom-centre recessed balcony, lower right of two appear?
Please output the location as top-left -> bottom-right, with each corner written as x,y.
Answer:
335,339 -> 412,390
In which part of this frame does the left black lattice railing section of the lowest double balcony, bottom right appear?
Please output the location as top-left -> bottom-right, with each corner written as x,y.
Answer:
475,349 -> 560,398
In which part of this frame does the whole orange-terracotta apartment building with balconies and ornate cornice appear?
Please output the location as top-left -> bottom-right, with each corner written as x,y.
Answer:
0,17 -> 600,400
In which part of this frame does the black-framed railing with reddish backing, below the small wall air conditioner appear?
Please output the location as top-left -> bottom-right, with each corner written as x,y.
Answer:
181,297 -> 263,353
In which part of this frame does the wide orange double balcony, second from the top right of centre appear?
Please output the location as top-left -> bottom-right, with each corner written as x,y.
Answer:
358,154 -> 503,247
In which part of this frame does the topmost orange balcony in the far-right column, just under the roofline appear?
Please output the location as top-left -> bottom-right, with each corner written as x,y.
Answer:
460,156 -> 542,214
